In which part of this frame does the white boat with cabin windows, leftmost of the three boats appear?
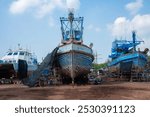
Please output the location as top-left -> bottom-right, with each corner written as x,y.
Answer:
0,46 -> 38,80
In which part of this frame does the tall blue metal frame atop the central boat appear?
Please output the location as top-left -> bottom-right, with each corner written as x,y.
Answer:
60,12 -> 83,43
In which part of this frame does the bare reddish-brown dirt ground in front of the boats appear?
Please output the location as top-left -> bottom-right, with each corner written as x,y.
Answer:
0,82 -> 150,100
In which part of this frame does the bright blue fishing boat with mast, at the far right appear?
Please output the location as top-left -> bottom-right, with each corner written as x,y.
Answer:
108,31 -> 149,73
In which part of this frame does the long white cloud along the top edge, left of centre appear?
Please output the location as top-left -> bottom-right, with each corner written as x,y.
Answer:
9,0 -> 80,17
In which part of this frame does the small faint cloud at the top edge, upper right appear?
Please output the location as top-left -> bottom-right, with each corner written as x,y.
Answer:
125,0 -> 143,15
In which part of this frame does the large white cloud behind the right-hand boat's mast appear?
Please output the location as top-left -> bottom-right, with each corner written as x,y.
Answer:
109,14 -> 150,50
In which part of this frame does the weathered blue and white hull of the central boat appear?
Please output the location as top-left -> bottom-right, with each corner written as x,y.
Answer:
57,44 -> 93,79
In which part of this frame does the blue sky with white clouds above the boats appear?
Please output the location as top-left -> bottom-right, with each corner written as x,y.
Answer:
0,0 -> 150,63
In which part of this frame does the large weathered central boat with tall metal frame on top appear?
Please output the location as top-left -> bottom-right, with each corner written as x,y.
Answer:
57,11 -> 94,83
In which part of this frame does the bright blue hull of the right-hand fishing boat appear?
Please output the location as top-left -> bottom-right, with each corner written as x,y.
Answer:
108,52 -> 147,72
